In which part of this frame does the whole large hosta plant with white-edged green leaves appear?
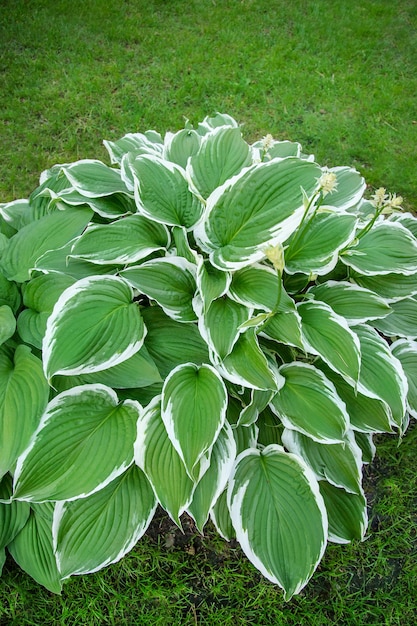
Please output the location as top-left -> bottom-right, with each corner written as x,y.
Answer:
0,114 -> 417,599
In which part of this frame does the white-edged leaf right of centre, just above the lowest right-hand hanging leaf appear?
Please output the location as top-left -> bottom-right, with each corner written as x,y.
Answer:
270,363 -> 349,443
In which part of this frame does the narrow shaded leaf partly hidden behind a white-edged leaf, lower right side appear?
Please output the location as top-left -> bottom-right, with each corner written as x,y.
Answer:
317,362 -> 392,433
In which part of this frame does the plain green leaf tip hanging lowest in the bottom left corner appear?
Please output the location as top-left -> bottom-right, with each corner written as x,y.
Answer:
7,503 -> 62,594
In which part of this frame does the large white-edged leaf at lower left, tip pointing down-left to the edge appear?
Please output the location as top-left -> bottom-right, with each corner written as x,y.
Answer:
14,384 -> 141,502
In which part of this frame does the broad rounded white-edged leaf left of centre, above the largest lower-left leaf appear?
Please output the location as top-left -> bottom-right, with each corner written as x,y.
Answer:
43,276 -> 146,379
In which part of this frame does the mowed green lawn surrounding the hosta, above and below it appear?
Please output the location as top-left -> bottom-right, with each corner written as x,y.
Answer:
0,0 -> 417,626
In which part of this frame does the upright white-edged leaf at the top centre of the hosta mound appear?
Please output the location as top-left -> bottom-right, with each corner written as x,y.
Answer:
187,126 -> 252,198
